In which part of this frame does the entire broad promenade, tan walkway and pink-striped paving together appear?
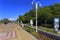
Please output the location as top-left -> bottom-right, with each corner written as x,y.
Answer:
0,23 -> 37,40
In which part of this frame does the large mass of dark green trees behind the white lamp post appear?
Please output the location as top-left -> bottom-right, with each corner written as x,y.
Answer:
17,3 -> 60,28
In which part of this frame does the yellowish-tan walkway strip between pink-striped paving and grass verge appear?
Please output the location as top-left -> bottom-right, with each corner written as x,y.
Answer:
14,24 -> 37,40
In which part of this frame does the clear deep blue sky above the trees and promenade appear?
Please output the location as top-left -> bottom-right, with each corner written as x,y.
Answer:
0,0 -> 60,20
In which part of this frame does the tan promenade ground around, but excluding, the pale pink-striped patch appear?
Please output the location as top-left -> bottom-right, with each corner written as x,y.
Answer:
0,23 -> 37,40
